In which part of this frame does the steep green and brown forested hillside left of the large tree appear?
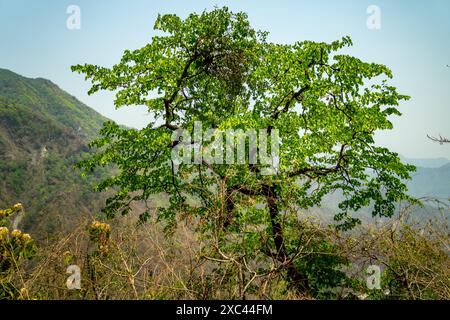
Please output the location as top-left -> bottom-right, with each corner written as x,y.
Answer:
0,69 -> 107,238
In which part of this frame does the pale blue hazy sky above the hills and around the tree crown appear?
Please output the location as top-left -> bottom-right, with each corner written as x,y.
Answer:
0,0 -> 450,159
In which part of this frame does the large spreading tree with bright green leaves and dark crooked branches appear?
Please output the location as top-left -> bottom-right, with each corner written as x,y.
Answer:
72,8 -> 413,292
